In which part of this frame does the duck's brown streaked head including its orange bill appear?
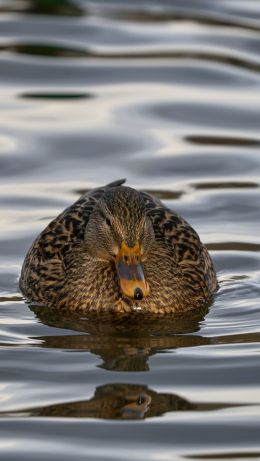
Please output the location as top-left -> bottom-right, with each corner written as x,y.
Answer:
85,186 -> 154,300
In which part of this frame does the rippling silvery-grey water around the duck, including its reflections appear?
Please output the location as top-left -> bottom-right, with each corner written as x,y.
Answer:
0,0 -> 260,461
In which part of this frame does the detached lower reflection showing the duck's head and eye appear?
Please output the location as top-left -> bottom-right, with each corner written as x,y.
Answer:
30,384 -> 195,419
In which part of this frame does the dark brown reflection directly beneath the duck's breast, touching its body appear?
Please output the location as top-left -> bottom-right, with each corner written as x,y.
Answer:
31,306 -> 210,372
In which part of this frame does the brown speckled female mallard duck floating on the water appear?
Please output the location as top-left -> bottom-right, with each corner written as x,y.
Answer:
20,180 -> 217,313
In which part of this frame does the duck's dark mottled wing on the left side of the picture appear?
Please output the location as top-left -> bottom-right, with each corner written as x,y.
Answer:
19,179 -> 125,301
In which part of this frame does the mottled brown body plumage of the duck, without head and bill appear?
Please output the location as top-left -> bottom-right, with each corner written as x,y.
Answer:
20,181 -> 217,313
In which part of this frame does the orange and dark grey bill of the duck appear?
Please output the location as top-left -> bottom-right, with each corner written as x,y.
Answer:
116,243 -> 150,300
